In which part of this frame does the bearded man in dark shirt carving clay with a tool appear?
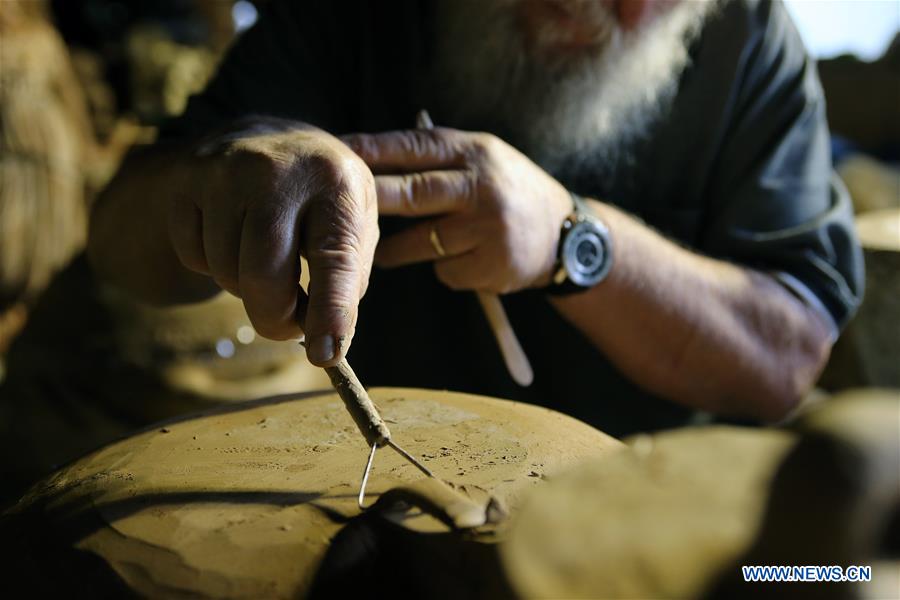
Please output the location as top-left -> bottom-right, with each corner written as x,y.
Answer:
89,0 -> 862,435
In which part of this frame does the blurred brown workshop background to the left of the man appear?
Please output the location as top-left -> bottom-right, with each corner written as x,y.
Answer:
0,0 -> 328,492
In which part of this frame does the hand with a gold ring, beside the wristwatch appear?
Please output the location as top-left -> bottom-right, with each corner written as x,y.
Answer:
342,128 -> 572,294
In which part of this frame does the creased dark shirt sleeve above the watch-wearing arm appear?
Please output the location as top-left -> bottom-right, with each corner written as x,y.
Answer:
700,0 -> 864,334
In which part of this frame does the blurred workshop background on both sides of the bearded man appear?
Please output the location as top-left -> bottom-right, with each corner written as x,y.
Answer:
0,0 -> 900,482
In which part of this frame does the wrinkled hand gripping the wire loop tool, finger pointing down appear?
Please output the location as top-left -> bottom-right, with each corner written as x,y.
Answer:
167,122 -> 378,366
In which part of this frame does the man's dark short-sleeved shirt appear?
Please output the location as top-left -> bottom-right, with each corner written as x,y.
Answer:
164,0 -> 863,435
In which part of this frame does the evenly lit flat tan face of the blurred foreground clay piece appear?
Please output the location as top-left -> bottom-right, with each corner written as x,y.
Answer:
501,427 -> 795,598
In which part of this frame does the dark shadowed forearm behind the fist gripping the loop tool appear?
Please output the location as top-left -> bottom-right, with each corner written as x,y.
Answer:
88,144 -> 219,304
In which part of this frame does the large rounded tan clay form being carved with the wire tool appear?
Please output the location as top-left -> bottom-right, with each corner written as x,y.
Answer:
7,389 -> 622,598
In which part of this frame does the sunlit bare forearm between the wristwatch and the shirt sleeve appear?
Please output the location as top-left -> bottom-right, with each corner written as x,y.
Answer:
551,202 -> 830,421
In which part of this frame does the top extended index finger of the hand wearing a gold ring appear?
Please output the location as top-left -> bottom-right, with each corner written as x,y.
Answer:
341,127 -> 465,173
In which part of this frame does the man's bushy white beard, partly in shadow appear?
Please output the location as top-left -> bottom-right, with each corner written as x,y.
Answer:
432,0 -> 719,171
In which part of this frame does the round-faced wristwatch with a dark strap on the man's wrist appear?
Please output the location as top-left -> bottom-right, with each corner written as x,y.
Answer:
546,193 -> 613,296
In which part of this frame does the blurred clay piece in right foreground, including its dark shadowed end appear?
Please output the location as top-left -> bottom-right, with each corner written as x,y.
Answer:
499,389 -> 900,600
